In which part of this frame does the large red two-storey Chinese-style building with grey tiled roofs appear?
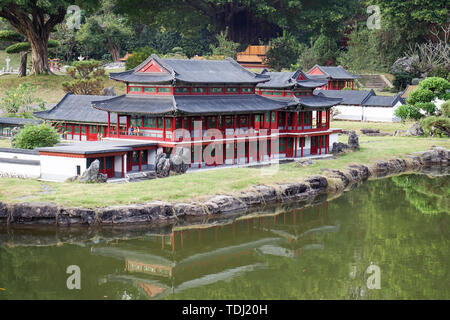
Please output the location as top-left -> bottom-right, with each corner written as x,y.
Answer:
35,55 -> 341,181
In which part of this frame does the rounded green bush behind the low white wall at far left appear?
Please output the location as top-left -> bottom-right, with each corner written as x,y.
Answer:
13,123 -> 59,149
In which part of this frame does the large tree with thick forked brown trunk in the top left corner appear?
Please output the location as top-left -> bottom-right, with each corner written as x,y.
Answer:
0,0 -> 98,74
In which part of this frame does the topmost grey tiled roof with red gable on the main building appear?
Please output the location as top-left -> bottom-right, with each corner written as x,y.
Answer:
110,55 -> 268,84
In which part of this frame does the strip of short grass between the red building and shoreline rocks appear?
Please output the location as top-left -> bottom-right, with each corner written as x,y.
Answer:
0,136 -> 450,207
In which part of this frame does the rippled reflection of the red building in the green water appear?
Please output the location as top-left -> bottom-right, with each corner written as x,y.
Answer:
91,202 -> 339,299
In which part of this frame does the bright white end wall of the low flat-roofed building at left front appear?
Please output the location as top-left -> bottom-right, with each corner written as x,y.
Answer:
40,155 -> 87,182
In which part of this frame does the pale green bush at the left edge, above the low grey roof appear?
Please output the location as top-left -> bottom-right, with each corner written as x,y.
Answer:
0,82 -> 45,118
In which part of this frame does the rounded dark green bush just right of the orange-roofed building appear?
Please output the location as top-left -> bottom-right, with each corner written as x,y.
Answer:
266,32 -> 301,71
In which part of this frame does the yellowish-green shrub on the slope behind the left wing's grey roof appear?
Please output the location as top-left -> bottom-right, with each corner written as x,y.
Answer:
62,60 -> 106,95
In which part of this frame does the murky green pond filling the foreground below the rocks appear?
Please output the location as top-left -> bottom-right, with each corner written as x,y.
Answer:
0,174 -> 450,299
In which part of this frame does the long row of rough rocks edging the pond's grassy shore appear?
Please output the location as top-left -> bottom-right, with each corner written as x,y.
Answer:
0,147 -> 450,226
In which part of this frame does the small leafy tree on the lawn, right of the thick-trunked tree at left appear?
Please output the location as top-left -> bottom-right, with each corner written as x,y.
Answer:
76,0 -> 133,62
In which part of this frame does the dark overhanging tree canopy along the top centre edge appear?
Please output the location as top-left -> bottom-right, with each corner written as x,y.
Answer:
116,0 -> 361,43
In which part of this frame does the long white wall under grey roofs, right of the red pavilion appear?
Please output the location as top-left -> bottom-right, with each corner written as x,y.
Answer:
334,104 -> 401,122
